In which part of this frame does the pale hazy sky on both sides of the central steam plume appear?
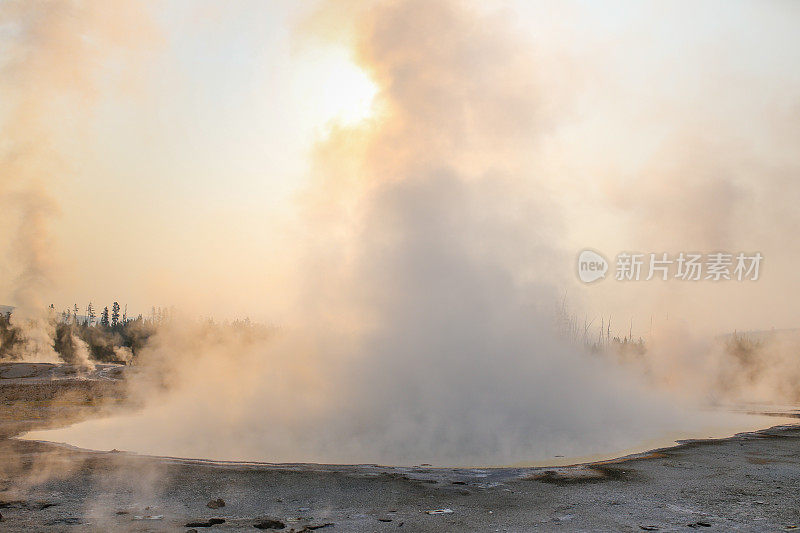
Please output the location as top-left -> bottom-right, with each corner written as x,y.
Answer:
0,0 -> 800,333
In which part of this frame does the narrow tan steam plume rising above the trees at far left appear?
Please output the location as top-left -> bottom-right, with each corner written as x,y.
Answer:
0,0 -> 153,361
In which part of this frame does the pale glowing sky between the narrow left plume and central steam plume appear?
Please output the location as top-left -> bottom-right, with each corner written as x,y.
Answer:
13,2 -> 374,316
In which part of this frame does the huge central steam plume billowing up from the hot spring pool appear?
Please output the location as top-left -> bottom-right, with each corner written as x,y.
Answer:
29,0 -> 764,465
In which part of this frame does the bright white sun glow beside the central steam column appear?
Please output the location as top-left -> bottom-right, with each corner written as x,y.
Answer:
295,48 -> 378,127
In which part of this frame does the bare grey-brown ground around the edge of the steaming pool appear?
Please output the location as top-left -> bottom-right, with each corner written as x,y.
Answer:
0,364 -> 800,532
